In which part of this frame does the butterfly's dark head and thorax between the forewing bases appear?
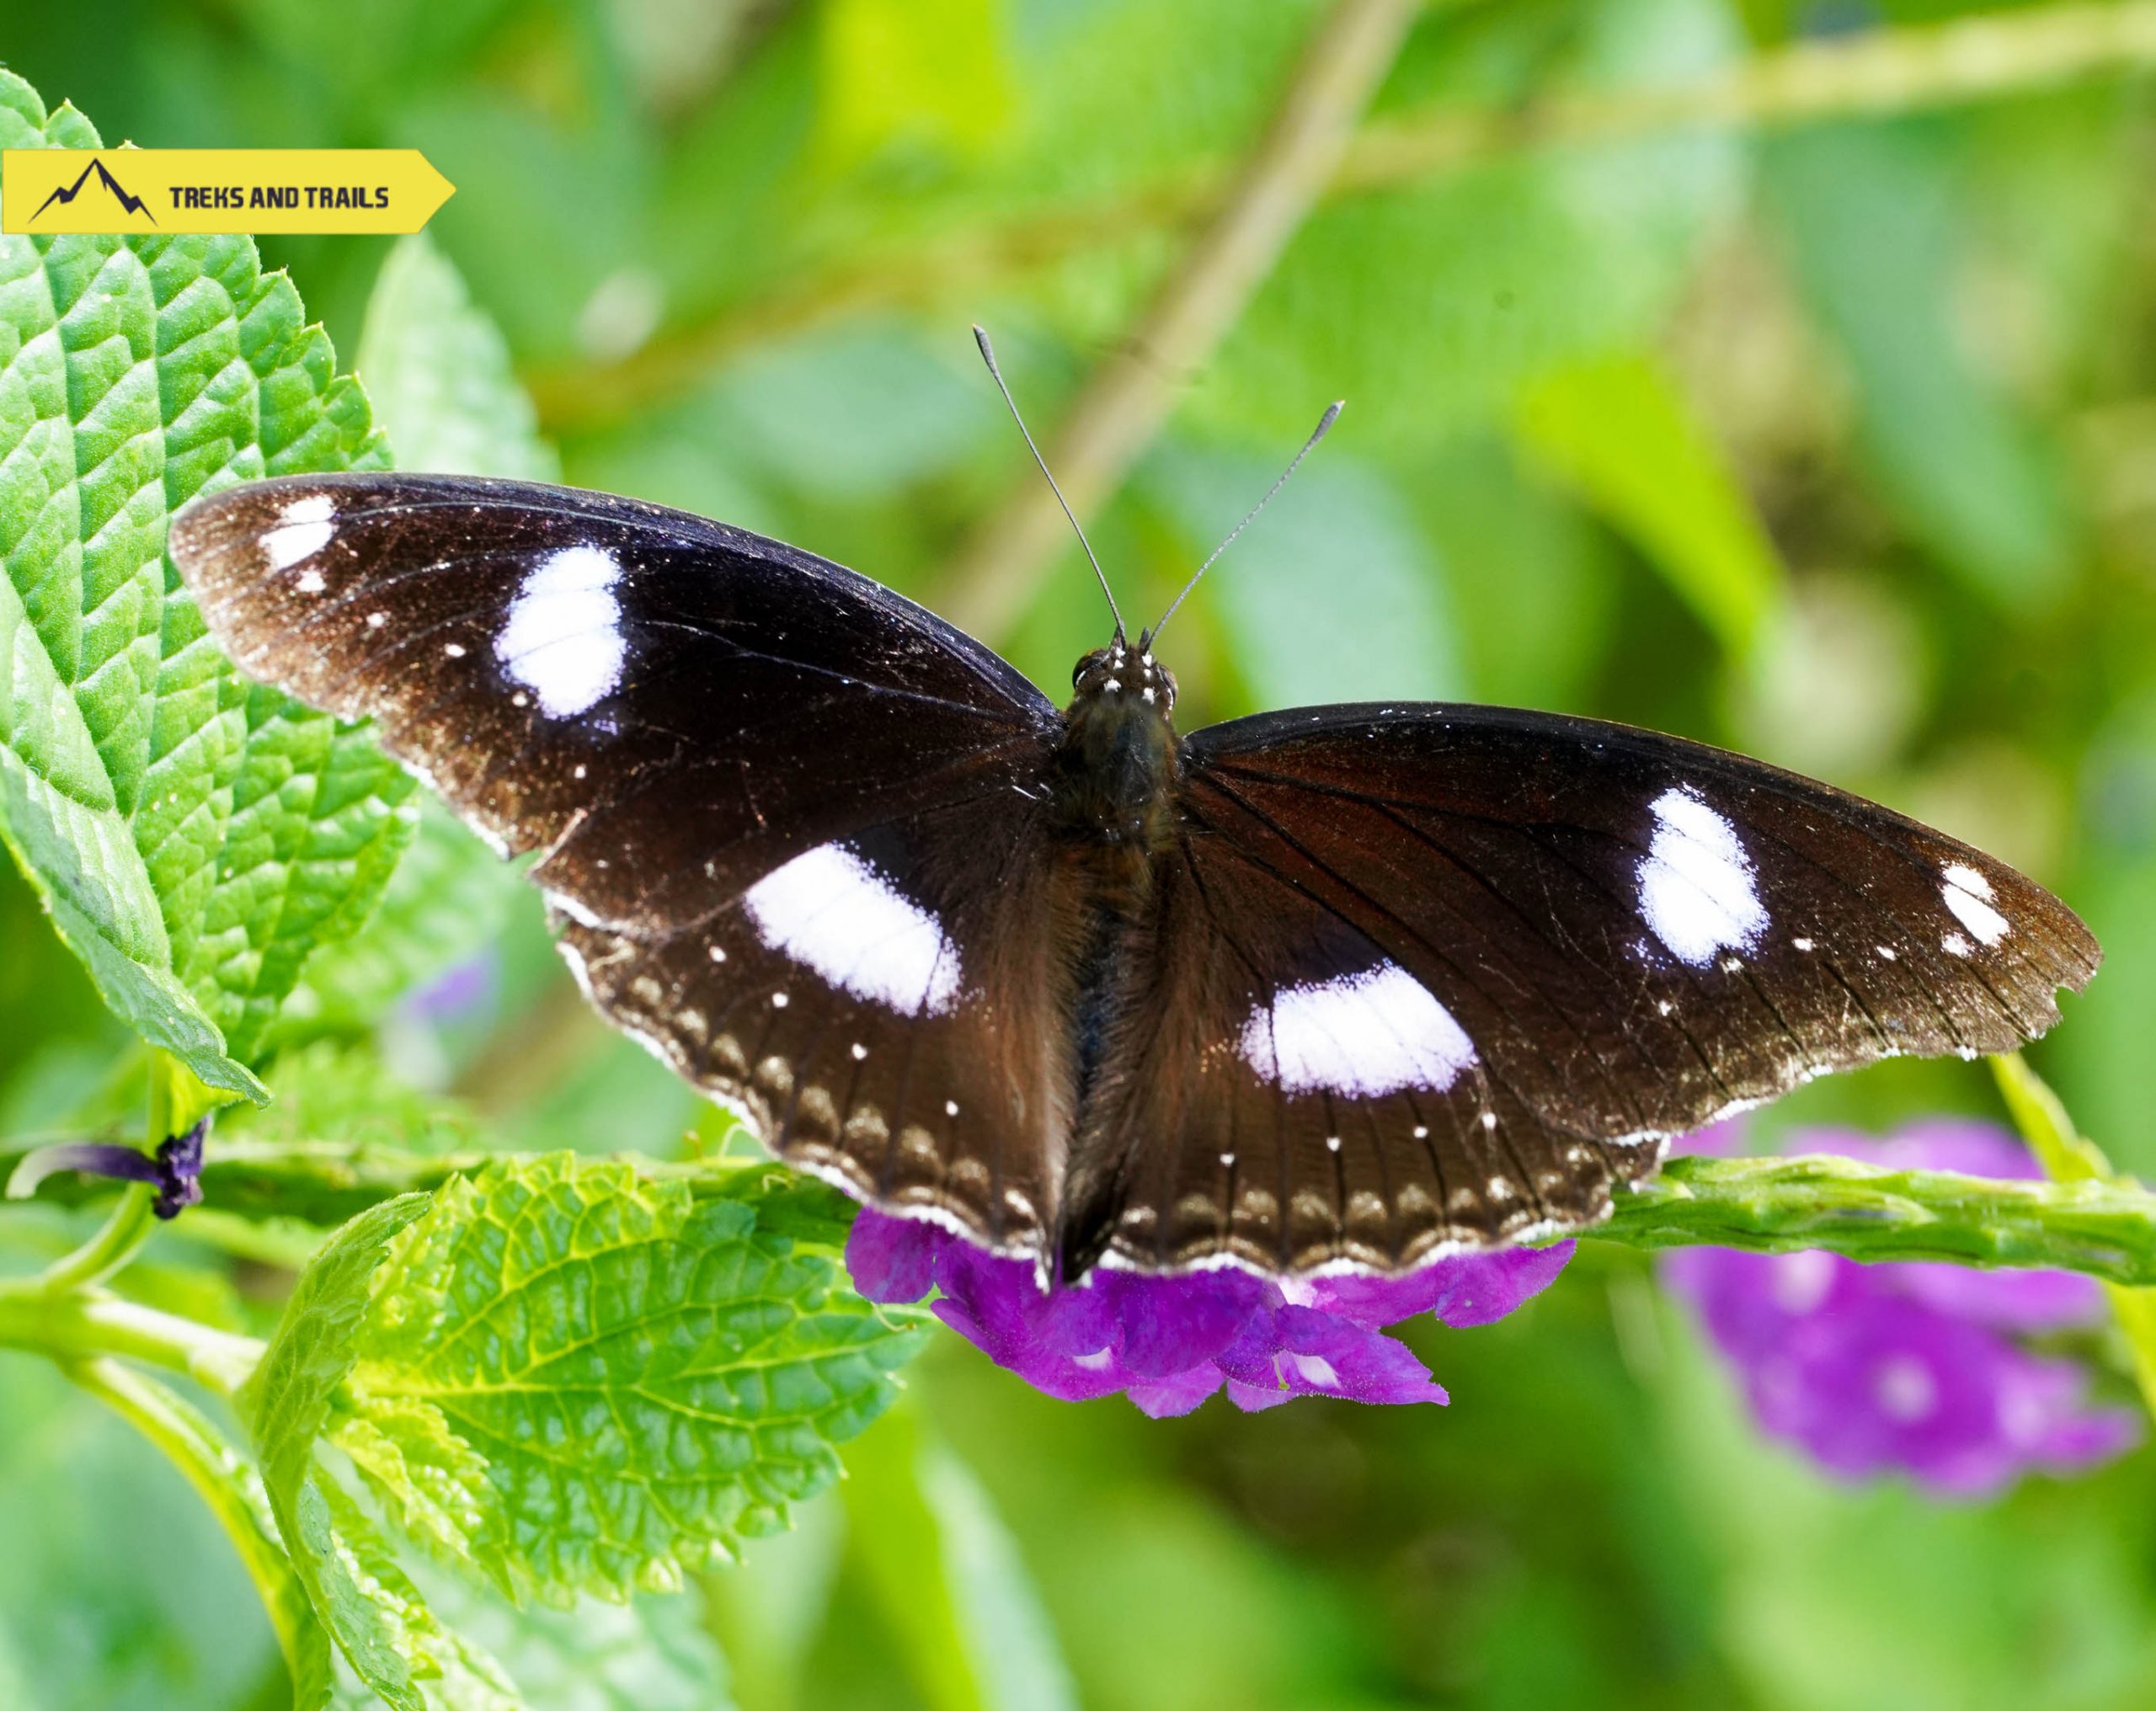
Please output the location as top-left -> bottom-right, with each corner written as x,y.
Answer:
1054,642 -> 1182,856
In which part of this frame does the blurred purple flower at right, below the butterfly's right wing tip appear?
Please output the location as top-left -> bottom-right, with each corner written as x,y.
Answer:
1662,1121 -> 2141,1495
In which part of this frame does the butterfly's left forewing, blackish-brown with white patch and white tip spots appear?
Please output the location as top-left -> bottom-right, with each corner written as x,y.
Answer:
173,477 -> 1056,926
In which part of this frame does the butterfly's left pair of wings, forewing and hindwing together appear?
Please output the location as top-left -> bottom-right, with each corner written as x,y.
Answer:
173,474 -> 1061,1245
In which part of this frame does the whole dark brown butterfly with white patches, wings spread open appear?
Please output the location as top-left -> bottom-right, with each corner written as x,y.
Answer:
170,336 -> 2100,1282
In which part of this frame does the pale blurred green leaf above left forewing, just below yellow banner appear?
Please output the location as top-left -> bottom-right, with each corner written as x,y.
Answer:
354,232 -> 561,481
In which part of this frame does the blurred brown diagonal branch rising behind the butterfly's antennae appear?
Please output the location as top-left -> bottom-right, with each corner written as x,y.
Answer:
938,0 -> 1418,636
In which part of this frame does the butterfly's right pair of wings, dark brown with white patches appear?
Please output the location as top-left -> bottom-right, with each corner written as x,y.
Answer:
1071,706 -> 2100,1269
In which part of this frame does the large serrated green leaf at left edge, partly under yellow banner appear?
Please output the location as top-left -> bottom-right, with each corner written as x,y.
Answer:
0,71 -> 412,1097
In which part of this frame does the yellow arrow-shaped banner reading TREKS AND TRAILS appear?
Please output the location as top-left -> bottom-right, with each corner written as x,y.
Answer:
0,149 -> 457,237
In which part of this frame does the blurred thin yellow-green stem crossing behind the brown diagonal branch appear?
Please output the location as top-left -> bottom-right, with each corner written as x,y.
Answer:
528,0 -> 2156,431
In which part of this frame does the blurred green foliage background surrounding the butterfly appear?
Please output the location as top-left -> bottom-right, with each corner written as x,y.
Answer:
13,0 -> 2156,1711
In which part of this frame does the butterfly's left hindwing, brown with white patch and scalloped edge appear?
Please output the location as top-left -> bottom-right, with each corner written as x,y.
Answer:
561,791 -> 1070,1254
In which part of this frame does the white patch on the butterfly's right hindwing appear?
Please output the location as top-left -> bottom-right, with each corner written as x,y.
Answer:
1237,961 -> 1475,1099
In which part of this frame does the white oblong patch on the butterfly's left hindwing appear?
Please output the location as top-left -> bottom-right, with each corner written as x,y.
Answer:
742,843 -> 959,1015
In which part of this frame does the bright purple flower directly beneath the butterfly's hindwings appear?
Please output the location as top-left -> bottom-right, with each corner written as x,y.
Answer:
846,1211 -> 1572,1418
